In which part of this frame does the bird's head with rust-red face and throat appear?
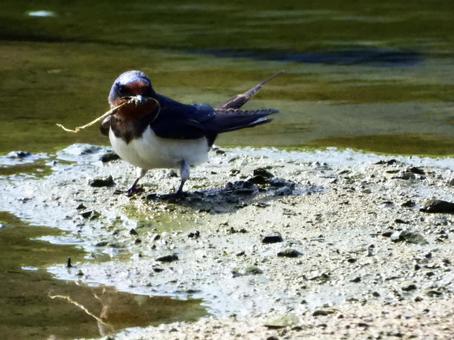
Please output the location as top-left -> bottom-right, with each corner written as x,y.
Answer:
108,71 -> 159,118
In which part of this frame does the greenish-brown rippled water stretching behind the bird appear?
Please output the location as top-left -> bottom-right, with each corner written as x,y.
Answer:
0,0 -> 454,155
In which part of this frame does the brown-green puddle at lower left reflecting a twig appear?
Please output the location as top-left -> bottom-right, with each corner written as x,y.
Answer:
0,212 -> 206,339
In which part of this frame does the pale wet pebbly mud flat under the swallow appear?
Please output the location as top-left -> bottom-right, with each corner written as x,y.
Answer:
0,145 -> 454,339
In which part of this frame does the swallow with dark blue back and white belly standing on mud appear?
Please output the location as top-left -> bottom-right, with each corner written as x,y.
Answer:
100,70 -> 281,196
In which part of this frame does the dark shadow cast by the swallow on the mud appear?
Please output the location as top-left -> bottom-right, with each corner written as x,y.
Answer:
146,175 -> 323,214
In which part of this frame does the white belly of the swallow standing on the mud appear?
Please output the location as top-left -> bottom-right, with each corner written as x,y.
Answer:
109,127 -> 209,170
